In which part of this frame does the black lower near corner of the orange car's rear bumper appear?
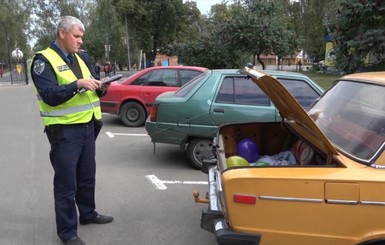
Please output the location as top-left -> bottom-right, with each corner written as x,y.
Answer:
201,210 -> 261,245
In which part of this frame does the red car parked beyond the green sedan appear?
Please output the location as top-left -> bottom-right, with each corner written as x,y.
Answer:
100,66 -> 207,127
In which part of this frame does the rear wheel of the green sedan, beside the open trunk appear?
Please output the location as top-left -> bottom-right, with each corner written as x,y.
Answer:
186,139 -> 214,169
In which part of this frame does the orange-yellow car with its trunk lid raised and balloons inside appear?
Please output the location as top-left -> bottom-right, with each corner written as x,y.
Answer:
194,68 -> 385,245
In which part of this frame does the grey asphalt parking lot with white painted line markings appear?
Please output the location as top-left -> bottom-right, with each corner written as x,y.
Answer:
0,85 -> 216,245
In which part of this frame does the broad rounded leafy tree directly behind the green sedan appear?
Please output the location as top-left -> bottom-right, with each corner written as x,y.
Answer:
167,0 -> 299,68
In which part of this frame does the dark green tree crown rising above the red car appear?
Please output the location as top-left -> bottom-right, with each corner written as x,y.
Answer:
113,0 -> 199,64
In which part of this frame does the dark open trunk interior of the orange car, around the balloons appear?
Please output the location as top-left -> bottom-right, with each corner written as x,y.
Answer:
215,123 -> 338,171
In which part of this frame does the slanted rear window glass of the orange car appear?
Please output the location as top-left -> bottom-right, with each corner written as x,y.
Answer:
308,81 -> 385,163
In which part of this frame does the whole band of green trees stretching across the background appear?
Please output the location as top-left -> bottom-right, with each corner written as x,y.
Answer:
11,0 -> 385,73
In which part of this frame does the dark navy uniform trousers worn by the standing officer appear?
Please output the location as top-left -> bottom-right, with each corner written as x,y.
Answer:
45,120 -> 97,240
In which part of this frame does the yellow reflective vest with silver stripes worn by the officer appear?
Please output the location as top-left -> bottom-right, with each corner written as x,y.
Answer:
35,48 -> 102,126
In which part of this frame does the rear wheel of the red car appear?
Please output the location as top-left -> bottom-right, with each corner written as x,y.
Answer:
120,102 -> 147,127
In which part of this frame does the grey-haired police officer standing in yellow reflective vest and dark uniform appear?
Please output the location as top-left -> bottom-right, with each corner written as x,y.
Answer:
31,16 -> 113,245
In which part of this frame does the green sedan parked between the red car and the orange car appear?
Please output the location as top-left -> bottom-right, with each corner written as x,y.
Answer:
145,69 -> 324,169
